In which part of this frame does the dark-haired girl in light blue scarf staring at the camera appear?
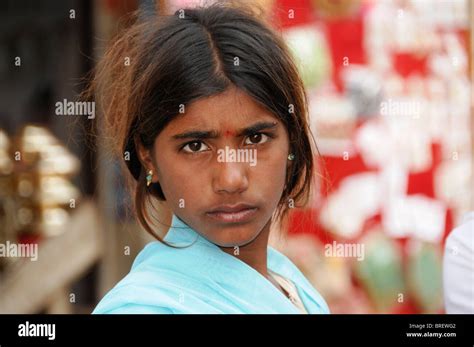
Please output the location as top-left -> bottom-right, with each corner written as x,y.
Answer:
93,3 -> 328,313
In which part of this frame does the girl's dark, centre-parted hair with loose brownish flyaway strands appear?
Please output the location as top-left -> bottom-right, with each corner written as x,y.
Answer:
91,2 -> 313,240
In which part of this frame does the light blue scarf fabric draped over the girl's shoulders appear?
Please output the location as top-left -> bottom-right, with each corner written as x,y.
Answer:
93,215 -> 329,314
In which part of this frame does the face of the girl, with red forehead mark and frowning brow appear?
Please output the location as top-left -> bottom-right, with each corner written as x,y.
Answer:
149,88 -> 289,247
